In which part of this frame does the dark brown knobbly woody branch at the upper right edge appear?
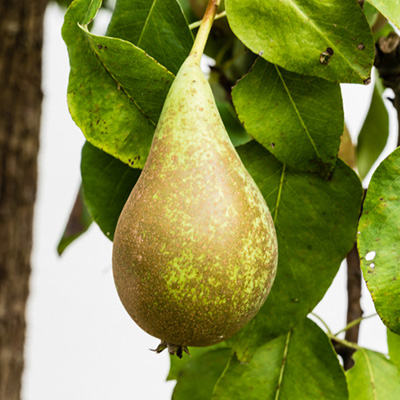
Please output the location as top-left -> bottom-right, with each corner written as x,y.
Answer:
374,32 -> 400,146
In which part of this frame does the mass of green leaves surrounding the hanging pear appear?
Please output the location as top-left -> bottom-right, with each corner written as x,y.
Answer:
63,0 -> 400,400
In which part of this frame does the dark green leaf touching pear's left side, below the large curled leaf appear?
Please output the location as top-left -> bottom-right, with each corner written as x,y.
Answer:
81,142 -> 141,240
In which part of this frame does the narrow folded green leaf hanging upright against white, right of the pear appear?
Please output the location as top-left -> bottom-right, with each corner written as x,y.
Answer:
357,77 -> 389,179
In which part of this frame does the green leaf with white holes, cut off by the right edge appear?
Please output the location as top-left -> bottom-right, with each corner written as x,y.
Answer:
358,148 -> 400,334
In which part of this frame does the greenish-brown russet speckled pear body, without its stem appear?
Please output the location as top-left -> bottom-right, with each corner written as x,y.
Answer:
113,52 -> 277,346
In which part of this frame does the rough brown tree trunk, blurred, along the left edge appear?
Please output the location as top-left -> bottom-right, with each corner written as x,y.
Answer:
0,0 -> 47,400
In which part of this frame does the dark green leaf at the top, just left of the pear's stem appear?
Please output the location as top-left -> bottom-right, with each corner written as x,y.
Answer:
107,0 -> 193,74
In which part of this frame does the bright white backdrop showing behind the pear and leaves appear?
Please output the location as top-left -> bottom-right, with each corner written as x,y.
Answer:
23,4 -> 397,400
